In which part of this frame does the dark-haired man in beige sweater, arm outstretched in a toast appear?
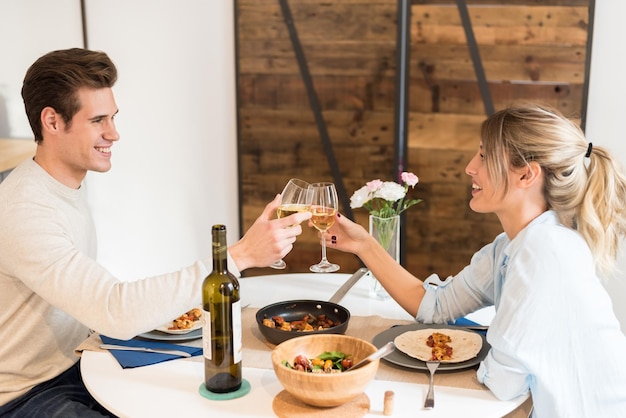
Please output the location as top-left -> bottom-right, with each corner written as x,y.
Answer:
0,48 -> 310,417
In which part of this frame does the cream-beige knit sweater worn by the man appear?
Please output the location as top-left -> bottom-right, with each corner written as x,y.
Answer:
0,159 -> 238,405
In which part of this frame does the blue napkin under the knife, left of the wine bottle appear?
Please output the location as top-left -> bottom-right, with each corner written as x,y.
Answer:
100,335 -> 202,369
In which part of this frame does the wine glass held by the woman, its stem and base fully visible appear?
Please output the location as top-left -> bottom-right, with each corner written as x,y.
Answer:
309,183 -> 339,273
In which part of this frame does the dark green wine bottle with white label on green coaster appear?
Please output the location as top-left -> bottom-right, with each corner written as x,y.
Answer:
202,225 -> 242,393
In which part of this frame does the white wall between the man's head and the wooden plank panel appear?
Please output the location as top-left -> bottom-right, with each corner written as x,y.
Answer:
87,0 -> 239,279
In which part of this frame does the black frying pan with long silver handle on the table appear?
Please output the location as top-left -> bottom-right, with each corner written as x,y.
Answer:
256,268 -> 368,344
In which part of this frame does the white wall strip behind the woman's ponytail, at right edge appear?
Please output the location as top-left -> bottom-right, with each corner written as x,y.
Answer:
586,0 -> 626,333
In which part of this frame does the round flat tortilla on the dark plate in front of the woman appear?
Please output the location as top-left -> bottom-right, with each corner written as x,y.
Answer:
394,328 -> 483,363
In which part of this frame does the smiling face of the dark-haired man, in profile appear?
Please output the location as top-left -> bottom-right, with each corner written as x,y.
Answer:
55,88 -> 119,185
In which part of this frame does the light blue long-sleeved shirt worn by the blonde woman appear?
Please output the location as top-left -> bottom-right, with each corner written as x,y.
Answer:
416,211 -> 626,418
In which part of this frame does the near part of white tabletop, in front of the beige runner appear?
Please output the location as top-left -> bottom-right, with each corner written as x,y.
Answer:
81,351 -> 525,418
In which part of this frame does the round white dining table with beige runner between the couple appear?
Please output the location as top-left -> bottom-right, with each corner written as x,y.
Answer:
78,273 -> 532,418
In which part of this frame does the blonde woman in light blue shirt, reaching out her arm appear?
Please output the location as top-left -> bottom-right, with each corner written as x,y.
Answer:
326,106 -> 626,418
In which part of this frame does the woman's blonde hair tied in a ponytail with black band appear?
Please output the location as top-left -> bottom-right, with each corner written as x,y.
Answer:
481,104 -> 626,273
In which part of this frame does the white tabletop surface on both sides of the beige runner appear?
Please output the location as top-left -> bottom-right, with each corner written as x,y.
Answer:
81,274 -> 526,418
